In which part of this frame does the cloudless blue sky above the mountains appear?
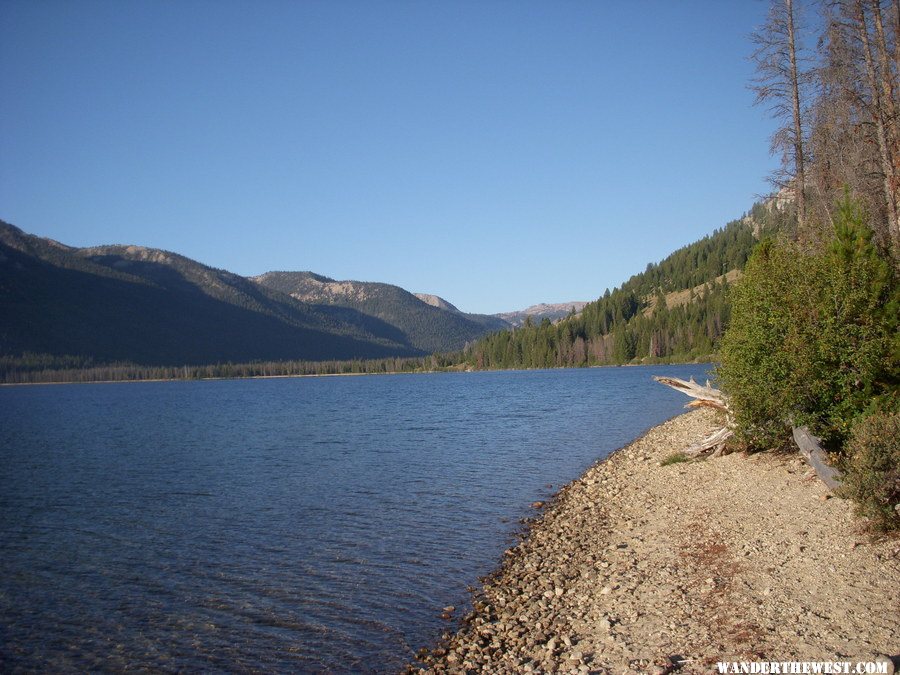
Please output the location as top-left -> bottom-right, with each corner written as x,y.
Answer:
0,0 -> 776,313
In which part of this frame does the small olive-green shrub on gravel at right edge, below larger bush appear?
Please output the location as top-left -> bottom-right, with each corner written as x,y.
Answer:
842,413 -> 900,530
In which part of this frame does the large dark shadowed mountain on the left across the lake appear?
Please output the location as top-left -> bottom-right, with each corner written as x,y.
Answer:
0,221 -> 423,365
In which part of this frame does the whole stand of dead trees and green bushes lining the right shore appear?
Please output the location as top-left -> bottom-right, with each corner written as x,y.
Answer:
719,0 -> 900,529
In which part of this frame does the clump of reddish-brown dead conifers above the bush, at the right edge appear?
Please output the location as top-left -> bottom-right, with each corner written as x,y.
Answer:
806,0 -> 900,265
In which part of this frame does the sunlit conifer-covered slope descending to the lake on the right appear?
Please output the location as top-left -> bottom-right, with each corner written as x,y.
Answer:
464,198 -> 791,368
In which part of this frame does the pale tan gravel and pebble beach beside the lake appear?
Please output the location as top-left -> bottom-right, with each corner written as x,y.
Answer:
408,410 -> 900,673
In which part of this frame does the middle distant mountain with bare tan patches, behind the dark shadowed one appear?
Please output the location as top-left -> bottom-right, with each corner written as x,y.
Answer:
252,272 -> 509,353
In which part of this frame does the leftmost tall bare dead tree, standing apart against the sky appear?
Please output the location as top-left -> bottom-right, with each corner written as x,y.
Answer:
752,0 -> 809,230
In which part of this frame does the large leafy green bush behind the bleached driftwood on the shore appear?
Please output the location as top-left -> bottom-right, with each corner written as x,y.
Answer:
718,198 -> 900,449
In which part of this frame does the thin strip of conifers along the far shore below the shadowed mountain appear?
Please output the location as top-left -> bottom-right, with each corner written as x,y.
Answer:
0,354 -> 460,384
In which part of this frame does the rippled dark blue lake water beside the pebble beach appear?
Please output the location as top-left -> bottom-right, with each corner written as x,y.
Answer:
0,366 -> 707,672
